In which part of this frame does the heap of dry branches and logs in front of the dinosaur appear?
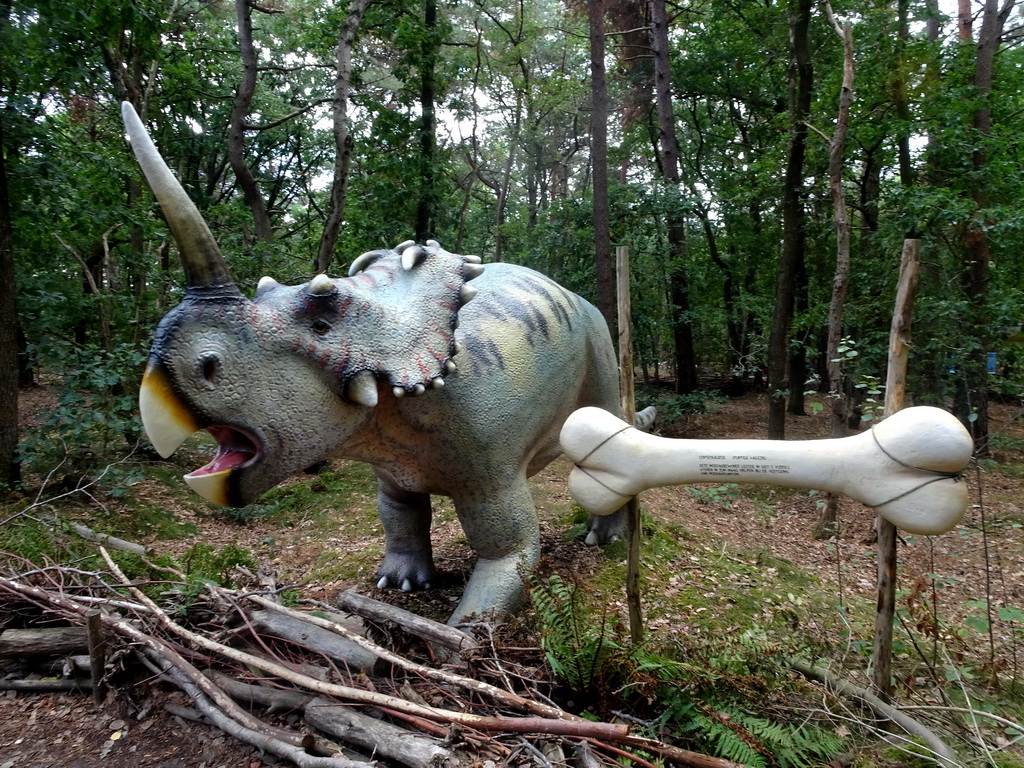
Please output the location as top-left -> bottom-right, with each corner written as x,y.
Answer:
0,549 -> 738,768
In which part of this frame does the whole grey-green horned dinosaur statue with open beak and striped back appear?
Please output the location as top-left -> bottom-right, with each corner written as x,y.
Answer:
123,103 -> 653,624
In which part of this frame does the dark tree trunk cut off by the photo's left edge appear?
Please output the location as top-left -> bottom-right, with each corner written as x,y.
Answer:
0,122 -> 20,486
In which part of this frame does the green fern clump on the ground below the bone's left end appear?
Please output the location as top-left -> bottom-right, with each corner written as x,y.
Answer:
527,575 -> 844,768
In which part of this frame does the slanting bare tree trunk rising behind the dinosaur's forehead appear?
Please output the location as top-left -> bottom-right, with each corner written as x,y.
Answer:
315,0 -> 370,274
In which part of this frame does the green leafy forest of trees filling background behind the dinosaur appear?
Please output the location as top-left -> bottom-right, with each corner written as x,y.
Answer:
0,0 -> 1024,481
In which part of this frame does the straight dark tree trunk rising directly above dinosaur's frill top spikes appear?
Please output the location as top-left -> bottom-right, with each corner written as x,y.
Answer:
416,0 -> 438,243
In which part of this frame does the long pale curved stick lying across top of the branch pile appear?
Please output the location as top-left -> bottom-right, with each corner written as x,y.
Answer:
99,548 -> 629,740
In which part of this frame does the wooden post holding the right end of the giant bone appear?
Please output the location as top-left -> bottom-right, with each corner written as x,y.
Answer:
871,239 -> 921,700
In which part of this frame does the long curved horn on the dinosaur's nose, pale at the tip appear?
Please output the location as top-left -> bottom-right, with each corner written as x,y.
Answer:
121,101 -> 242,297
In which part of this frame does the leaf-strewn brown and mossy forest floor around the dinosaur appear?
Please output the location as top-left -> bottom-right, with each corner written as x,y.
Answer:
0,390 -> 1024,768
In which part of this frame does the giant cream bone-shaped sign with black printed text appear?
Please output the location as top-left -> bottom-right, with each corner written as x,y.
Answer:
561,407 -> 974,535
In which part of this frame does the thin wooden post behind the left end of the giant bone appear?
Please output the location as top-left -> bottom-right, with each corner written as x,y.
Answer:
615,246 -> 643,643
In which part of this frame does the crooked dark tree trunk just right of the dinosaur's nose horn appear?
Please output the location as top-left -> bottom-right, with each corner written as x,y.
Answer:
227,0 -> 273,243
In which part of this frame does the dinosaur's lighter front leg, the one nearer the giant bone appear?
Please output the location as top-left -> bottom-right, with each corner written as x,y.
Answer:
449,477 -> 541,626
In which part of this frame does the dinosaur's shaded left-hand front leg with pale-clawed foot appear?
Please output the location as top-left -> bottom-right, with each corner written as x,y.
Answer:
377,473 -> 437,592
